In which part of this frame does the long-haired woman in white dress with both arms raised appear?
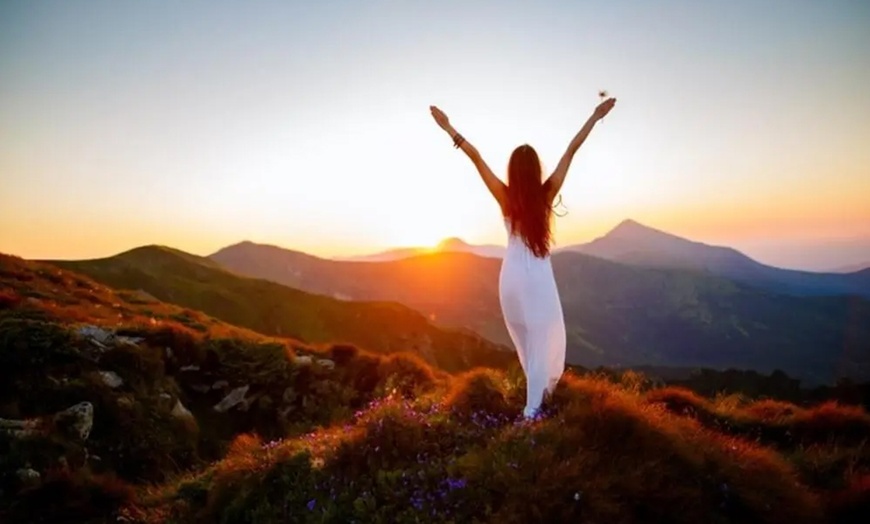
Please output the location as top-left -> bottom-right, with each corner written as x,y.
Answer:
429,98 -> 616,418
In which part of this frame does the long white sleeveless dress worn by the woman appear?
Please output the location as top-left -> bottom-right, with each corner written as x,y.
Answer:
498,219 -> 566,417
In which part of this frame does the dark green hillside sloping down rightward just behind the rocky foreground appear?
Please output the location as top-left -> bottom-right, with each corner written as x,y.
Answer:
52,246 -> 515,371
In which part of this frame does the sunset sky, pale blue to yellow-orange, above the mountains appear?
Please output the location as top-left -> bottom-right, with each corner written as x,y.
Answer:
0,0 -> 870,269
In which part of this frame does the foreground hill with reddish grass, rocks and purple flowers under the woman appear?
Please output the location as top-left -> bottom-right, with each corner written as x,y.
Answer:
0,256 -> 870,524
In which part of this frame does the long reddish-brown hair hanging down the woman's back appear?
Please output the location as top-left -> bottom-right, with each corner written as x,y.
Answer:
504,144 -> 553,258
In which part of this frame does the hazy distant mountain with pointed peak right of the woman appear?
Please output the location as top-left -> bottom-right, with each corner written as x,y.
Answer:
560,220 -> 870,298
